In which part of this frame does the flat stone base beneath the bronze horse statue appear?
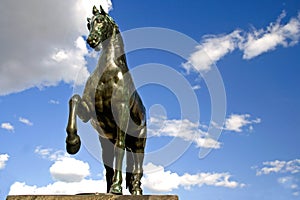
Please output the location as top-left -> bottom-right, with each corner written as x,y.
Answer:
6,193 -> 178,200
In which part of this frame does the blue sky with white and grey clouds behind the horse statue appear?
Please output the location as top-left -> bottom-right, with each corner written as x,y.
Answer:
0,0 -> 300,200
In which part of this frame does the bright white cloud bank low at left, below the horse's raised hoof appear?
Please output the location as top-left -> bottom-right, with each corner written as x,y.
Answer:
9,146 -> 135,195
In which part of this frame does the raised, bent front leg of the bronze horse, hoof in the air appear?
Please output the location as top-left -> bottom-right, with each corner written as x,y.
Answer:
66,94 -> 90,154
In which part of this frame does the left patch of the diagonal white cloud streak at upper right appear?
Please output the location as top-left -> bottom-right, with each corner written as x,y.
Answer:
183,30 -> 241,71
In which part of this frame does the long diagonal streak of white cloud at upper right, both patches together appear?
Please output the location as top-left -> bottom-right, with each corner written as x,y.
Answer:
182,12 -> 300,72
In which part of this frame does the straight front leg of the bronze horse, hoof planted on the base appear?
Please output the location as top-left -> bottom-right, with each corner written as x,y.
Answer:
110,103 -> 130,194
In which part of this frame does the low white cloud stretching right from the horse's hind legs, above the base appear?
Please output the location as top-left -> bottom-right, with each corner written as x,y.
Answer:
142,163 -> 245,193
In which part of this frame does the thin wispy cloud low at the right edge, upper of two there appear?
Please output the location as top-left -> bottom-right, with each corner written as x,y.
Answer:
256,159 -> 300,176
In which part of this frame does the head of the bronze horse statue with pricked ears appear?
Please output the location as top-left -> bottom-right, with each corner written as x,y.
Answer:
87,6 -> 118,50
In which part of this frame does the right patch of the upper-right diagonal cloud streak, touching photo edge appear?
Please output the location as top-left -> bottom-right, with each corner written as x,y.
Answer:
240,13 -> 300,59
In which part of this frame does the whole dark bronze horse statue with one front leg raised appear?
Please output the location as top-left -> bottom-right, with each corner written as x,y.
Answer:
66,6 -> 147,195
